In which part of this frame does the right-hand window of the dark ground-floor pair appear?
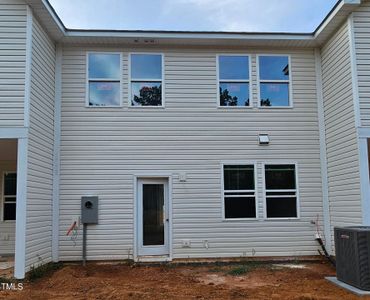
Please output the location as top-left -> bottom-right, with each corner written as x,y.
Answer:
265,164 -> 298,218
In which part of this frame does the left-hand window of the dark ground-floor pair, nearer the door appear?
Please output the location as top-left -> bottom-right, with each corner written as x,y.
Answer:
223,165 -> 256,219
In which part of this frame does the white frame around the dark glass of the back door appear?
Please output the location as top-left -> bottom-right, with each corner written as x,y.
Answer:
133,172 -> 172,261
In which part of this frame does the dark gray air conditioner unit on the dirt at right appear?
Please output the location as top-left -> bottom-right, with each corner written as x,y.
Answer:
334,226 -> 370,291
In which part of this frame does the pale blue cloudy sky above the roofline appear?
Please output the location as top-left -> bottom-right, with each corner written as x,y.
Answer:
49,0 -> 337,32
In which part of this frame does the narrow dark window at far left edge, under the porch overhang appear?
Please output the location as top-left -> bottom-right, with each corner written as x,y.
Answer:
3,172 -> 17,221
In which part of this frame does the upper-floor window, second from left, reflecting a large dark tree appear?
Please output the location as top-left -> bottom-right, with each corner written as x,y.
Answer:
130,54 -> 163,106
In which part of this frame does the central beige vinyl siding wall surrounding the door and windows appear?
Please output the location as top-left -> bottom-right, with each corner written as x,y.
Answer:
60,46 -> 322,260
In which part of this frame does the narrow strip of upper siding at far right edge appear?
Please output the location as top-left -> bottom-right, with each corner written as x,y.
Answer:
353,1 -> 370,127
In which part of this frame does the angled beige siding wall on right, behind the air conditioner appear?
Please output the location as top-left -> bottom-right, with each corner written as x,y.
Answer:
322,23 -> 362,252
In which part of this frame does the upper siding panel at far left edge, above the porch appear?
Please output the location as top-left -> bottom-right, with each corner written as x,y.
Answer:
0,0 -> 27,127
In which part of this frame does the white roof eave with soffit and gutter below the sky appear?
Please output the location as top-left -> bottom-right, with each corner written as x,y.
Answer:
25,0 -> 361,47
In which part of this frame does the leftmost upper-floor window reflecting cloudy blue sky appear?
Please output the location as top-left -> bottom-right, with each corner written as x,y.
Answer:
87,53 -> 121,107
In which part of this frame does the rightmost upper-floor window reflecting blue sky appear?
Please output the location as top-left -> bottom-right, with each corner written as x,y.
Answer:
258,55 -> 291,107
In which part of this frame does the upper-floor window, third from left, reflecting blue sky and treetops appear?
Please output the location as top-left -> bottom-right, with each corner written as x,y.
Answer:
218,55 -> 250,107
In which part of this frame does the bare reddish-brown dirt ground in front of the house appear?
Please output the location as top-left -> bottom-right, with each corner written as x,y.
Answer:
0,262 -> 370,300
